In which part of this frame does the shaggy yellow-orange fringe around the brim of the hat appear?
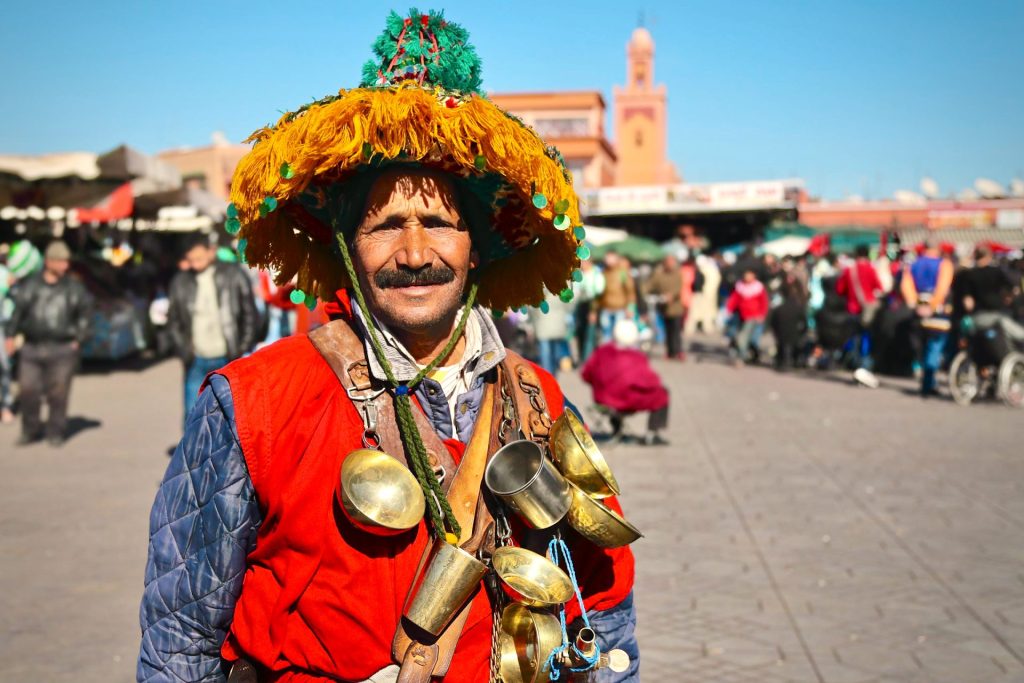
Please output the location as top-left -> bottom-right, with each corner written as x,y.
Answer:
231,84 -> 581,310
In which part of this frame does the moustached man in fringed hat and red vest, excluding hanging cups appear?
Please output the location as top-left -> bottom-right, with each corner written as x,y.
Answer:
138,13 -> 639,683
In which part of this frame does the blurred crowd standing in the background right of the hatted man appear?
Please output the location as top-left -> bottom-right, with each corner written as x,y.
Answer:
512,236 -> 1024,405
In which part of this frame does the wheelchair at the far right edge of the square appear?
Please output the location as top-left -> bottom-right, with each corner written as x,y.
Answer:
949,317 -> 1024,408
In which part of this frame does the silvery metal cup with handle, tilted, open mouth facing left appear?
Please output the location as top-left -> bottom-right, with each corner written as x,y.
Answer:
483,440 -> 572,528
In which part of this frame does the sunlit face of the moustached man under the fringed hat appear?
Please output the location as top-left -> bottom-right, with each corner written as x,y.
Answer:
353,170 -> 478,333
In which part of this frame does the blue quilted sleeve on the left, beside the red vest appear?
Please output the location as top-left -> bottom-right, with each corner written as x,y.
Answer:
136,375 -> 260,683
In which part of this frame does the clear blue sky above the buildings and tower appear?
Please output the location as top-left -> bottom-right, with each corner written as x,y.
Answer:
0,0 -> 1024,198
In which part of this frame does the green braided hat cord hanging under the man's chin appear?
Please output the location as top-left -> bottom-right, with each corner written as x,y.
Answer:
337,232 -> 477,538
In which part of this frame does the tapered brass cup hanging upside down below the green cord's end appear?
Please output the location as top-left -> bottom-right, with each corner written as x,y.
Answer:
406,539 -> 487,636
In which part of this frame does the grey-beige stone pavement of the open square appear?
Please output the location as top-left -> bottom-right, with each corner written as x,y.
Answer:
0,348 -> 1024,683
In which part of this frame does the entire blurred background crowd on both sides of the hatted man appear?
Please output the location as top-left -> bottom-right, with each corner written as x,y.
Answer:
0,231 -> 1024,444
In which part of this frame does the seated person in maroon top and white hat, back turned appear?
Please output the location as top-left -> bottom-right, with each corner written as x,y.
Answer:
583,319 -> 669,445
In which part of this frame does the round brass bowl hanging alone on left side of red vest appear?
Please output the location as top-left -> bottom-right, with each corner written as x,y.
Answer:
338,449 -> 427,536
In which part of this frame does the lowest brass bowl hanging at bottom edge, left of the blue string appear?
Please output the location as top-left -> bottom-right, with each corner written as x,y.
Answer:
498,602 -> 562,683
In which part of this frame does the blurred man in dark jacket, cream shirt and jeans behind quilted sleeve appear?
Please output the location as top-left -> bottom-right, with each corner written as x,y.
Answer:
167,234 -> 259,420
